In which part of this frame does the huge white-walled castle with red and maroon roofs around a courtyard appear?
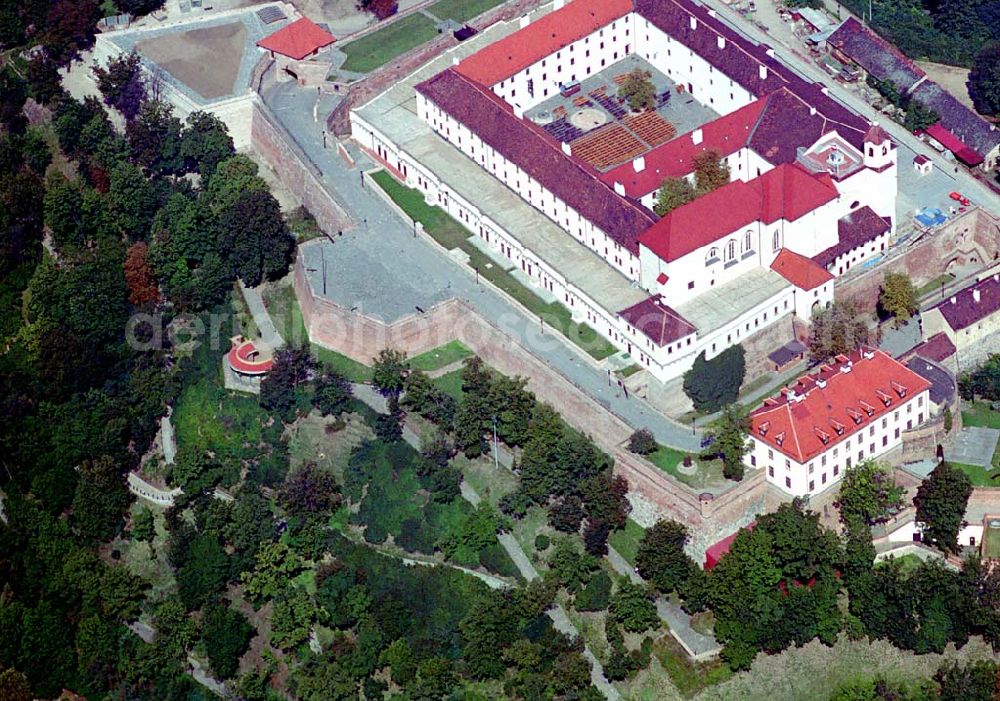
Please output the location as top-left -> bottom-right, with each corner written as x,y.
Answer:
351,0 -> 897,381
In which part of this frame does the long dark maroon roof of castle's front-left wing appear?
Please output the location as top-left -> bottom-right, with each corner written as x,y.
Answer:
416,67 -> 656,253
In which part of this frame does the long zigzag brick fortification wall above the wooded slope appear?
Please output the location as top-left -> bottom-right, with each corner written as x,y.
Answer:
294,244 -> 777,561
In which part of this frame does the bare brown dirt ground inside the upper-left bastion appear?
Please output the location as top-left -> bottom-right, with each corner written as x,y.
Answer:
136,22 -> 247,100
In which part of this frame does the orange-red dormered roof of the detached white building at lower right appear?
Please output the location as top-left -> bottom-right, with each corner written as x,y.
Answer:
750,347 -> 931,463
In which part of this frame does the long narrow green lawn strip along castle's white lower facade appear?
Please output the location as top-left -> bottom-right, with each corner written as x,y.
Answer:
371,170 -> 617,360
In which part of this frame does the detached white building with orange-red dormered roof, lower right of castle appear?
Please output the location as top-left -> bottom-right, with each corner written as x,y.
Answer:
745,346 -> 931,496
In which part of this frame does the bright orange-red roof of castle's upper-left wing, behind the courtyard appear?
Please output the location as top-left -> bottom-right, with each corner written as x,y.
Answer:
455,0 -> 632,86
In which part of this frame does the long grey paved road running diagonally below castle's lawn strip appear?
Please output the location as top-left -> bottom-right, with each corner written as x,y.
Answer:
264,83 -> 701,452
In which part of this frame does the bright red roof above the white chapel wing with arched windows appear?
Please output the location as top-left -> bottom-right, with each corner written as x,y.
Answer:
639,163 -> 838,261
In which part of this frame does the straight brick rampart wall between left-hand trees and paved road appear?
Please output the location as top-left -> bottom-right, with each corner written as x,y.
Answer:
250,99 -> 354,234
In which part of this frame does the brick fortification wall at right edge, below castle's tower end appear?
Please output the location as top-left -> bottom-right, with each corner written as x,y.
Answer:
834,207 -> 1000,312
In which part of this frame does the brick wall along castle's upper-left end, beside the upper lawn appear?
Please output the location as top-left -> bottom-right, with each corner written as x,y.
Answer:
326,0 -> 543,136
